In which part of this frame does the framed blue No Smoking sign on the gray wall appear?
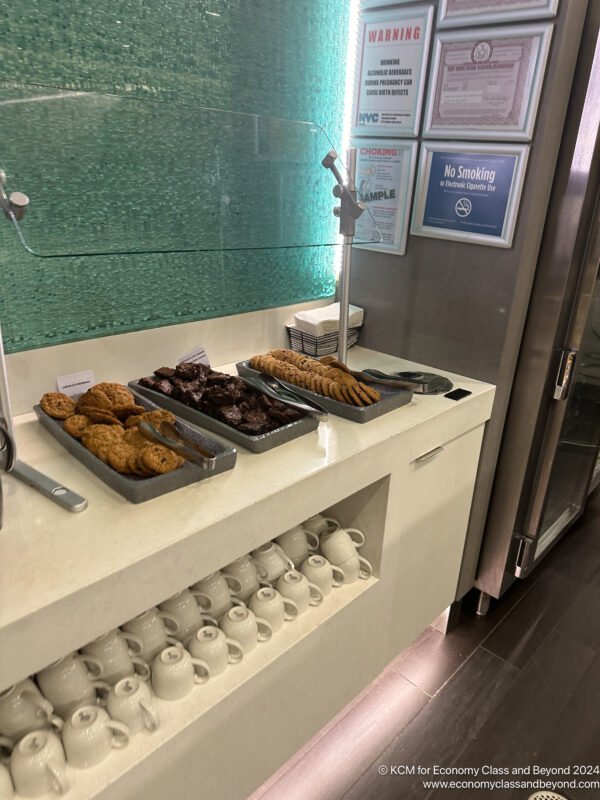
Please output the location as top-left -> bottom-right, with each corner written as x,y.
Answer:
411,142 -> 529,247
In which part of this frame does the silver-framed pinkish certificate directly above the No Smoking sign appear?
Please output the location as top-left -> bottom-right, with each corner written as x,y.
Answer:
423,23 -> 553,141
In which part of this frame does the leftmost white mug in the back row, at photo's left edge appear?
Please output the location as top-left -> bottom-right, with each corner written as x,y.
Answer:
0,679 -> 62,747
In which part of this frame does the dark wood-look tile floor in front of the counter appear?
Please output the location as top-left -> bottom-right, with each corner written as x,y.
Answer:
253,492 -> 600,800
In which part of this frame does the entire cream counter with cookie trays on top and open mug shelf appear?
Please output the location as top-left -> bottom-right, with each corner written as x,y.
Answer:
0,348 -> 494,800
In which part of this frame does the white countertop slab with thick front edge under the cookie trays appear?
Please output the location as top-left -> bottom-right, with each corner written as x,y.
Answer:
0,347 -> 494,689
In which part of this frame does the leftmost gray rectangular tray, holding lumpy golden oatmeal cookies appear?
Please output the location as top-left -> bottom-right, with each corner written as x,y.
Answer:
34,396 -> 237,503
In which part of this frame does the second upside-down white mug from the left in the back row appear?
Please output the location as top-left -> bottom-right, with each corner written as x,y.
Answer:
36,653 -> 110,719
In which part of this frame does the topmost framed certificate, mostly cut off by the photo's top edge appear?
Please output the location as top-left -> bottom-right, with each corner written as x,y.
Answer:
437,0 -> 558,28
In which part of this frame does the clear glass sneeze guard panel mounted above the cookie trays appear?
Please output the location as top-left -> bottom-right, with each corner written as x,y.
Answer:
0,86 -> 382,258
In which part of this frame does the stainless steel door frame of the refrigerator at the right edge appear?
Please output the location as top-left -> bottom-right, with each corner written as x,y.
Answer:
475,10 -> 600,597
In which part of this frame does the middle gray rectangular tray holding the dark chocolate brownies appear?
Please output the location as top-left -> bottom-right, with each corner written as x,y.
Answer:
128,381 -> 319,453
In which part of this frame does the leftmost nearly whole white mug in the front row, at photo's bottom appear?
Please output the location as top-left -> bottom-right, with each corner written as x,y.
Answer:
10,731 -> 70,797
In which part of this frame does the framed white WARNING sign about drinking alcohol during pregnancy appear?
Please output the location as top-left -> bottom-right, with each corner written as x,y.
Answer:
352,6 -> 433,136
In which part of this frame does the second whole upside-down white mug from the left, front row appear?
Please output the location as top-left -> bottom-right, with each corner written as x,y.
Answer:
62,706 -> 130,769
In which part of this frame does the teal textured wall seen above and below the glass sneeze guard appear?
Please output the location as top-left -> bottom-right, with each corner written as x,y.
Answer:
0,0 -> 350,352
